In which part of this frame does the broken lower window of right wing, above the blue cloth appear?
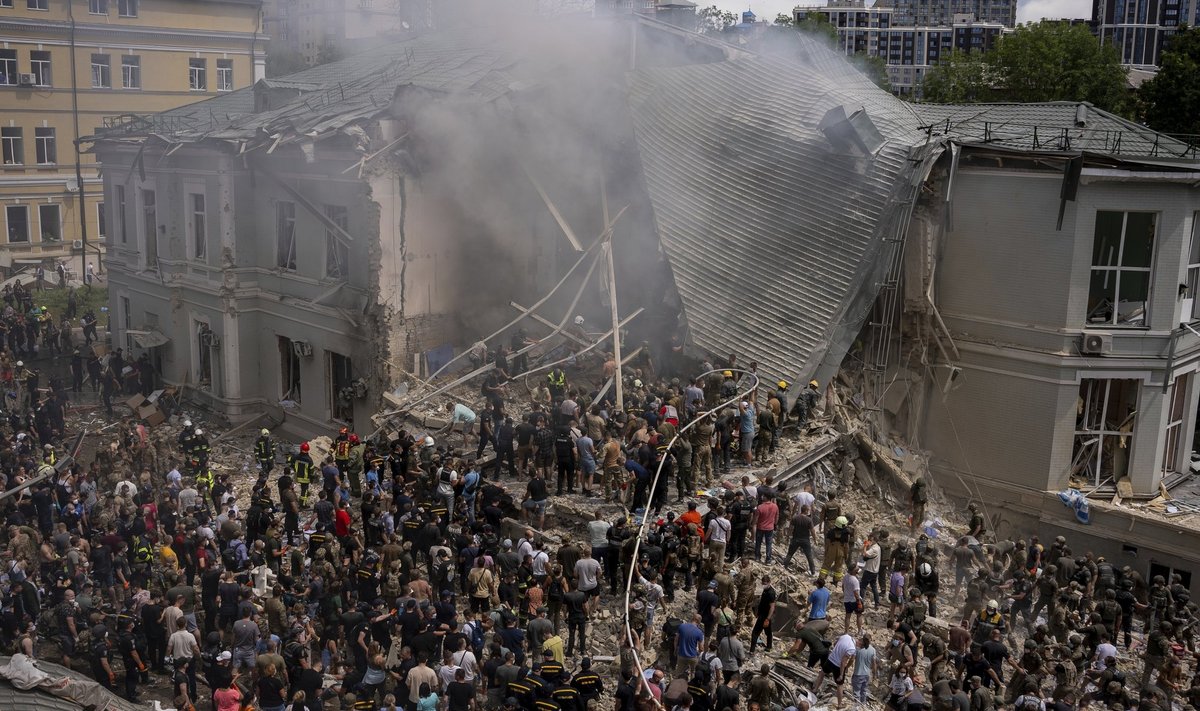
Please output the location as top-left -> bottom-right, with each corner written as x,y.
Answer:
1070,378 -> 1141,486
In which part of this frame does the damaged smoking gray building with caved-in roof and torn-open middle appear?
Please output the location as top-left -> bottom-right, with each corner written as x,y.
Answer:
91,16 -> 1200,588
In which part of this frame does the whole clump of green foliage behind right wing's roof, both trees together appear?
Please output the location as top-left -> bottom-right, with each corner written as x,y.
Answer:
922,22 -> 1128,113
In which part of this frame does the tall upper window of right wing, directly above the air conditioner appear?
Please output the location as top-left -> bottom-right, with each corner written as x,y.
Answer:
1087,210 -> 1158,325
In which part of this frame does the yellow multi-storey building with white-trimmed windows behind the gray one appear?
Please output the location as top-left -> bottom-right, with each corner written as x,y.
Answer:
0,0 -> 266,276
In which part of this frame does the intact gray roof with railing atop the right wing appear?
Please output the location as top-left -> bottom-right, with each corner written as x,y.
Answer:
912,101 -> 1195,159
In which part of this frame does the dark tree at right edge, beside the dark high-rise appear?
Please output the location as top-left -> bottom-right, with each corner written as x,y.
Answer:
1138,28 -> 1200,133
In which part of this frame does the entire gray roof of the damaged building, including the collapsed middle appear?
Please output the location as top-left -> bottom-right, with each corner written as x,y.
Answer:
87,18 -> 1187,381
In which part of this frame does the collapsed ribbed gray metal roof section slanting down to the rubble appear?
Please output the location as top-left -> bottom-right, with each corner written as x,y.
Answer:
630,45 -> 926,380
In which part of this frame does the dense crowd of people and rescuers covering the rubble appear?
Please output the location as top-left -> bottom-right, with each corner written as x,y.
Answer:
0,354 -> 1200,711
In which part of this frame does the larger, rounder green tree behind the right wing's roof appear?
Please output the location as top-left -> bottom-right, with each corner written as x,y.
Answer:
984,22 -> 1128,113
